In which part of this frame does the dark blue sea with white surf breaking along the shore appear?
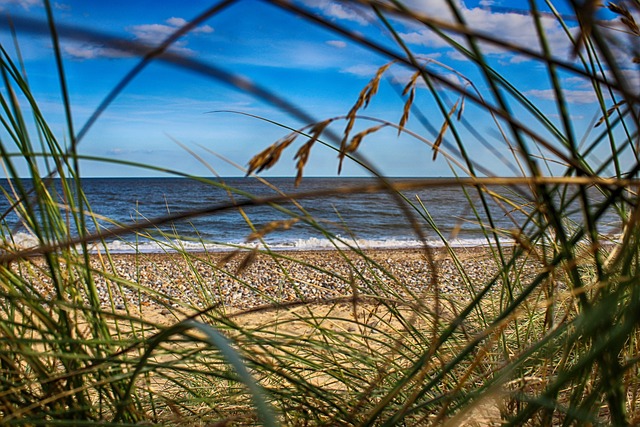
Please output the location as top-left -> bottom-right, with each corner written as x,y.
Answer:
0,177 -> 620,253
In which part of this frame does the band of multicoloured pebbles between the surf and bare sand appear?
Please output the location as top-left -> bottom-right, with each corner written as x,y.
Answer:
75,247 -> 520,313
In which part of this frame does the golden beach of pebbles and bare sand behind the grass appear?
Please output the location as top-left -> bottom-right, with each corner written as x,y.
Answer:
101,248 -> 510,426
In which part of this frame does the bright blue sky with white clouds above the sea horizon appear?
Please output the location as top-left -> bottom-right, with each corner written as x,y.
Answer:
0,0 -> 638,177
